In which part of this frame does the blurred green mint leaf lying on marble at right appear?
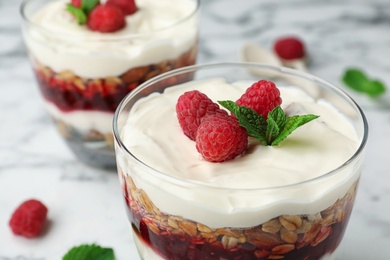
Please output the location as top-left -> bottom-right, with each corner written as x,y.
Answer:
342,68 -> 386,97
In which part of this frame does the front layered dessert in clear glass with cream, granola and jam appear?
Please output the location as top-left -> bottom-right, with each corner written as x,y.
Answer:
113,63 -> 368,260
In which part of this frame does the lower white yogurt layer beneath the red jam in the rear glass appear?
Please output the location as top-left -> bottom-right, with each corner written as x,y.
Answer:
45,101 -> 113,134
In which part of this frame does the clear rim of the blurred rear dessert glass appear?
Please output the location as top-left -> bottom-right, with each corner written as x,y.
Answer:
19,0 -> 200,42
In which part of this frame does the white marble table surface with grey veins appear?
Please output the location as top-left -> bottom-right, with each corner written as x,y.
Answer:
0,0 -> 390,260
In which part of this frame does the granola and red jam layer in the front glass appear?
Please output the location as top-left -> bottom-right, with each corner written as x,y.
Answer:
120,171 -> 358,260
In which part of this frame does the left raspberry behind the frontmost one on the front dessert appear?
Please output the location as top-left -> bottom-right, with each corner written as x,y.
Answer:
176,90 -> 227,140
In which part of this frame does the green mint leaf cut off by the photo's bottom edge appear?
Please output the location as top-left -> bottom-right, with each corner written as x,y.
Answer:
62,244 -> 115,260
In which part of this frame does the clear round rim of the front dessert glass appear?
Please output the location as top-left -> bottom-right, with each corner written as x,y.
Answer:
113,62 -> 368,191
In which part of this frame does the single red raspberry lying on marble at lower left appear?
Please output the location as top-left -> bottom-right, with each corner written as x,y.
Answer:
9,199 -> 47,238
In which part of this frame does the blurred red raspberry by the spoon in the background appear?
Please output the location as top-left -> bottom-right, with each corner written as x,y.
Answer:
274,37 -> 305,60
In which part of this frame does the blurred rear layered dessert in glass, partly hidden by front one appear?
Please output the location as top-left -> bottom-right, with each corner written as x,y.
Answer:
21,0 -> 199,169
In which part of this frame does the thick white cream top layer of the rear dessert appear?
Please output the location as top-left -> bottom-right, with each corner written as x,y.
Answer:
24,0 -> 197,78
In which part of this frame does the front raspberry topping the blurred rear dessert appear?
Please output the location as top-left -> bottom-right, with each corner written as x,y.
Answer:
87,5 -> 126,32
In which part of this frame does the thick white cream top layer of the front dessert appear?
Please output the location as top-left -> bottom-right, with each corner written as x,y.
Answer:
118,79 -> 360,228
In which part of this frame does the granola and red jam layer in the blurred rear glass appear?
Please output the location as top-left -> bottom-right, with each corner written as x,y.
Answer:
30,46 -> 197,112
